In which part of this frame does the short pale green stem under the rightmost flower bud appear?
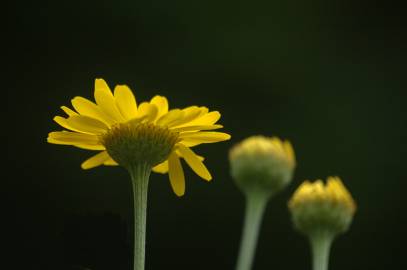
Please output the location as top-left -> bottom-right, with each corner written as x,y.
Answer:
310,231 -> 333,270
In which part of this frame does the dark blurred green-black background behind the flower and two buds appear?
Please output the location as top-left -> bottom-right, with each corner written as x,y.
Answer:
2,0 -> 407,270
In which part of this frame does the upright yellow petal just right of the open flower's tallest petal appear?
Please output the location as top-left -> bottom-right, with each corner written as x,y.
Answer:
114,85 -> 137,120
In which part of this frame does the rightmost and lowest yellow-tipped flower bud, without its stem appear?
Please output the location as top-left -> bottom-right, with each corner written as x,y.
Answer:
288,177 -> 356,234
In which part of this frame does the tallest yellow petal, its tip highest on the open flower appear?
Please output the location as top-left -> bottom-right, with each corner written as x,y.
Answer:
94,79 -> 124,122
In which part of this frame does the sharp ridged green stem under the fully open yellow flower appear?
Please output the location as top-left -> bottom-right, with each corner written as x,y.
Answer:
129,164 -> 151,270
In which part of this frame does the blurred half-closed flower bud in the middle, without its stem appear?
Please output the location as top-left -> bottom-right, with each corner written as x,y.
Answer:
229,136 -> 295,194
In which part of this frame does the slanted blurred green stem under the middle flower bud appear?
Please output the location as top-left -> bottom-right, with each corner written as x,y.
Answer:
236,192 -> 269,270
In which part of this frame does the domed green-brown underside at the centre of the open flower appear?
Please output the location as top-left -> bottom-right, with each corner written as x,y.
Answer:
102,122 -> 178,167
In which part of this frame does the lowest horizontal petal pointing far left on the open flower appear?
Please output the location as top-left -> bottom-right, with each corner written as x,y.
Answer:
47,131 -> 101,145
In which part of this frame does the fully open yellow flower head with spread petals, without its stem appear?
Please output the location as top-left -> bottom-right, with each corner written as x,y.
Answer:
47,79 -> 230,196
